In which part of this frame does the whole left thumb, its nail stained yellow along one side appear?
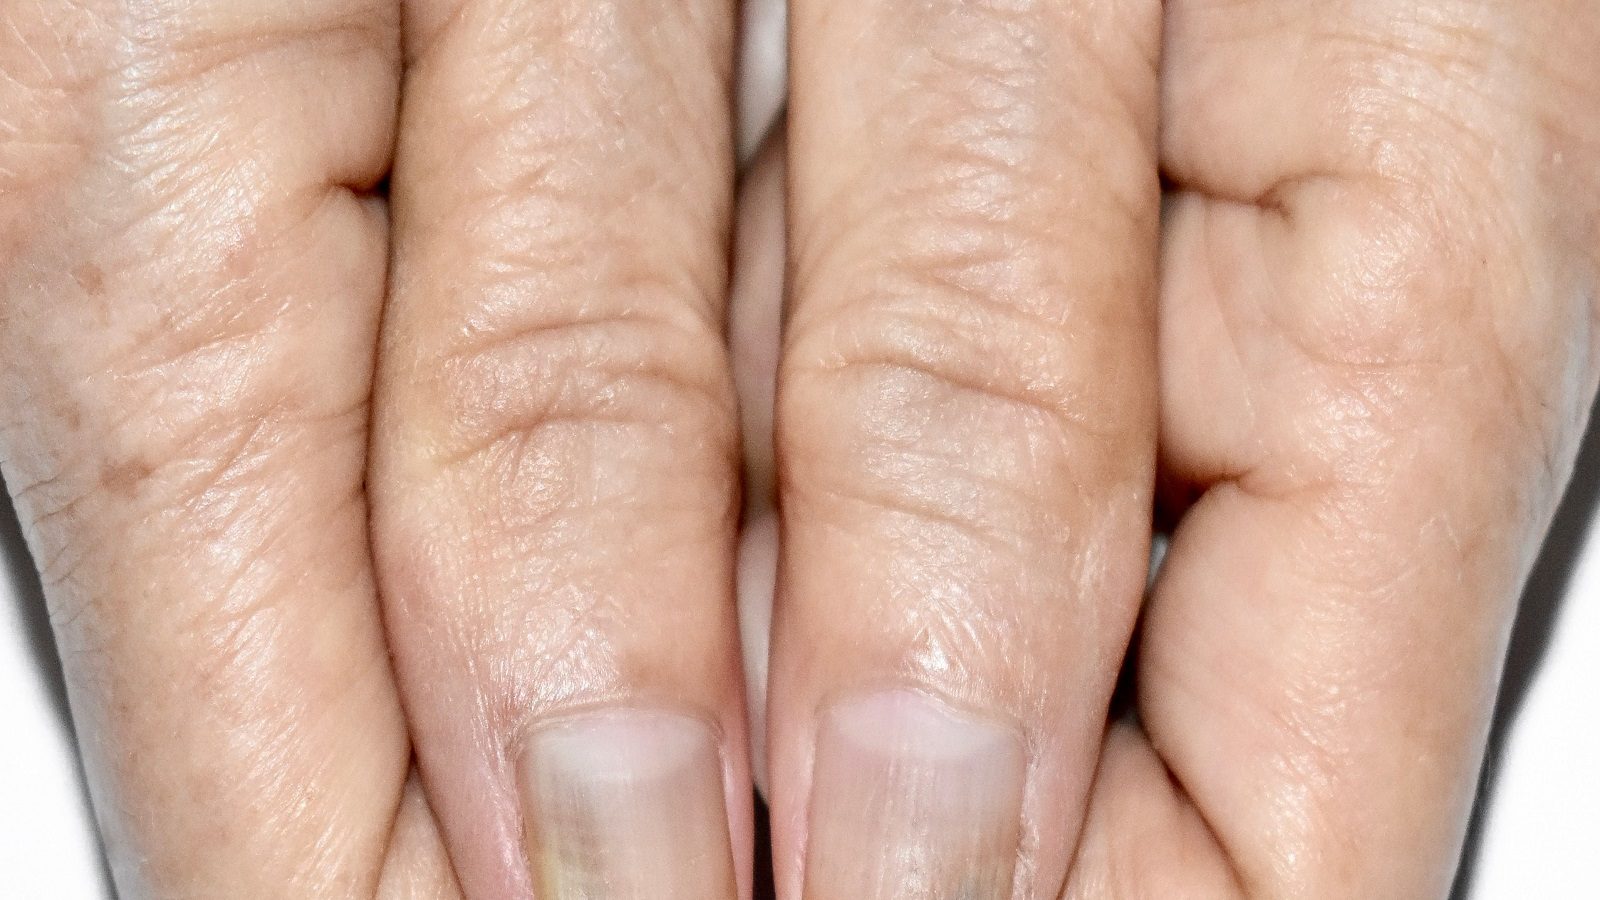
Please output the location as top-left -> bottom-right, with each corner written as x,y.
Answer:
373,0 -> 750,898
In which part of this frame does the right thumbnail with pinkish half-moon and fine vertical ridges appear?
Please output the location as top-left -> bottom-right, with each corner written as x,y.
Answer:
805,690 -> 1026,900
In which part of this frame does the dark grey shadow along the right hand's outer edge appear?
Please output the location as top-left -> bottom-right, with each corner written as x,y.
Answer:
1450,404 -> 1600,900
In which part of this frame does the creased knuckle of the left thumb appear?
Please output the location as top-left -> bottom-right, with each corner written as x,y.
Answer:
408,301 -> 736,508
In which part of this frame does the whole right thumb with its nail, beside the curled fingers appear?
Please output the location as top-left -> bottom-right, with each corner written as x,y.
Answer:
770,0 -> 1160,900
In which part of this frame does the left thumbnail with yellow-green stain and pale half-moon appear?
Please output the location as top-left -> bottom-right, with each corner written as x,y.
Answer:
522,709 -> 738,900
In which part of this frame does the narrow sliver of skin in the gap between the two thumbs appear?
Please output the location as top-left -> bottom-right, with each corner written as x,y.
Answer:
728,128 -> 786,790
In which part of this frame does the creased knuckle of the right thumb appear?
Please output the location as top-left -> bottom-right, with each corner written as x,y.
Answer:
778,262 -> 1154,549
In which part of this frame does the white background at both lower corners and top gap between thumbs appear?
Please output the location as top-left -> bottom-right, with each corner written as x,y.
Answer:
0,0 -> 1600,900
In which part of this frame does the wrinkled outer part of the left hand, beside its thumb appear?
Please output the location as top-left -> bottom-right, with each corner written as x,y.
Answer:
0,0 -> 408,897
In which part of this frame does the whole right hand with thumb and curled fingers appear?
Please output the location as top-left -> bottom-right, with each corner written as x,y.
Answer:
742,0 -> 1600,900
